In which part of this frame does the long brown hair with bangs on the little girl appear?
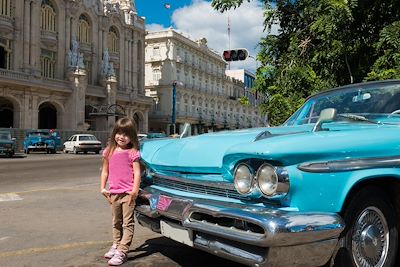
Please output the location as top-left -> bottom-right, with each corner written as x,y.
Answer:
106,118 -> 139,158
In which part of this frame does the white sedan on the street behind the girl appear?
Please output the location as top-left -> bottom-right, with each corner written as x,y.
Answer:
64,134 -> 101,154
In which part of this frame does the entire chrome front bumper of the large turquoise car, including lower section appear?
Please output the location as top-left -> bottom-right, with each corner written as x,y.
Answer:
136,186 -> 344,266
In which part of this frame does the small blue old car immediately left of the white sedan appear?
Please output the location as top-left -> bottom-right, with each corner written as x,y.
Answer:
24,130 -> 56,154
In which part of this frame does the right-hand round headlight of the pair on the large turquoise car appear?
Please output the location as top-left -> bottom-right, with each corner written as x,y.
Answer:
256,164 -> 278,196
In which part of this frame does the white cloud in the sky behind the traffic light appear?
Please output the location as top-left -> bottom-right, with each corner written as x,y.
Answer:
170,0 -> 266,71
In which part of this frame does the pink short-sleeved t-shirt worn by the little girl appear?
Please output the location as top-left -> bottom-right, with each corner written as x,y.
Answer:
103,148 -> 140,194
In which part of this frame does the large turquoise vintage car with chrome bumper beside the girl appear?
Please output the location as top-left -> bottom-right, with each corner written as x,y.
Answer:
136,80 -> 400,267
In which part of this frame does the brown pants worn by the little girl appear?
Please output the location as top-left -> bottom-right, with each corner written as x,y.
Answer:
111,194 -> 135,254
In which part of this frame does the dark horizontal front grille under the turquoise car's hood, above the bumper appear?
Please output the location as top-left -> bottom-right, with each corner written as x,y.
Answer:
153,175 -> 249,200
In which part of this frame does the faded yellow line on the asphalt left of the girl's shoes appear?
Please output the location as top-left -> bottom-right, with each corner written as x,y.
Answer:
0,241 -> 111,258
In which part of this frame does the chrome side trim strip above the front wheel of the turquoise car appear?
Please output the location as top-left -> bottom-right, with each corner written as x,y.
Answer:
297,156 -> 400,173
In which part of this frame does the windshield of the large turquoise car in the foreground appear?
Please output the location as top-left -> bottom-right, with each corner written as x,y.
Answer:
284,82 -> 400,125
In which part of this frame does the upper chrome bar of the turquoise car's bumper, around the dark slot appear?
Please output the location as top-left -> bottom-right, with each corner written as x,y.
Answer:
135,186 -> 344,247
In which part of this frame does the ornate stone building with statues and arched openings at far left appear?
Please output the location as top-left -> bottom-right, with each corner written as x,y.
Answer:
0,0 -> 152,134
